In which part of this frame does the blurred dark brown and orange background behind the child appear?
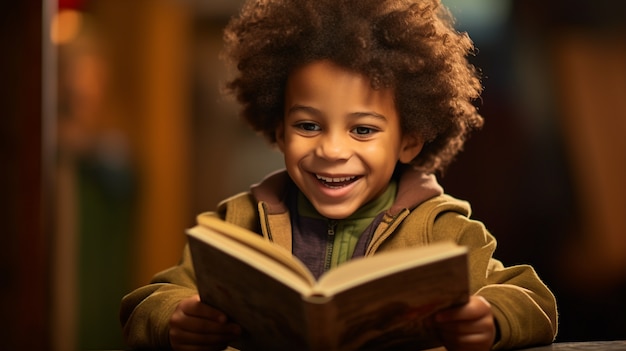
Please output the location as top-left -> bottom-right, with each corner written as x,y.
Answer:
0,0 -> 626,351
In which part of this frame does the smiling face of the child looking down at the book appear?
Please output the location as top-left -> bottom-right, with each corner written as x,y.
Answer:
276,61 -> 422,219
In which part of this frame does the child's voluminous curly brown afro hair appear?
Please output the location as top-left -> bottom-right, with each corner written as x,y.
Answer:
223,0 -> 483,172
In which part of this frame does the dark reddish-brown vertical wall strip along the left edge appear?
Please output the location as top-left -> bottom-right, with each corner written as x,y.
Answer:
0,1 -> 48,350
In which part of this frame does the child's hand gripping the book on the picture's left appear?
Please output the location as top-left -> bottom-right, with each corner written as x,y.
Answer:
170,295 -> 241,351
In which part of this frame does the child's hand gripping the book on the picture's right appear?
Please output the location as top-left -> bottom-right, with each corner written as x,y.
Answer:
434,296 -> 496,351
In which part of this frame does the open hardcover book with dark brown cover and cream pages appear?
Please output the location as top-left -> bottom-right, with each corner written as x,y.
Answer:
187,216 -> 469,350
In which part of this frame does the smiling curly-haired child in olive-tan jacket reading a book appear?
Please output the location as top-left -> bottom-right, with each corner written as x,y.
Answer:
121,0 -> 557,350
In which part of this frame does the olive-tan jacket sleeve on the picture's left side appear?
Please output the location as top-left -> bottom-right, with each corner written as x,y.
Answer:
120,247 -> 197,349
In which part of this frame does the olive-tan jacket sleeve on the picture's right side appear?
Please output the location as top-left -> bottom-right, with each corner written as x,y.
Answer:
431,211 -> 558,350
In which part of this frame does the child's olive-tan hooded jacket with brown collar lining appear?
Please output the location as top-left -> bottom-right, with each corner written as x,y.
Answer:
120,169 -> 557,349
